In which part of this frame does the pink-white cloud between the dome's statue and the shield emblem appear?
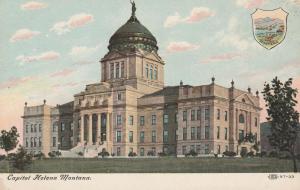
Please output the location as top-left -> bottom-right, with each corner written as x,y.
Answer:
164,7 -> 215,28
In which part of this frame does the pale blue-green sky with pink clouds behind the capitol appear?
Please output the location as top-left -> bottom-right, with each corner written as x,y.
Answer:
0,0 -> 300,140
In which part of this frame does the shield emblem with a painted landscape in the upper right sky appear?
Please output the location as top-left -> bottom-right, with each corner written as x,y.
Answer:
252,8 -> 288,49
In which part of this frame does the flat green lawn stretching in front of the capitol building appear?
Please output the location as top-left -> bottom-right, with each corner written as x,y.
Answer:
0,158 -> 300,173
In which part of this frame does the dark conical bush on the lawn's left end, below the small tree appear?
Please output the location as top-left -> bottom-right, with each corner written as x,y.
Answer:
11,146 -> 32,170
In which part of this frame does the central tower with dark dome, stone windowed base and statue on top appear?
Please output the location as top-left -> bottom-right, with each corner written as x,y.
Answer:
100,2 -> 164,94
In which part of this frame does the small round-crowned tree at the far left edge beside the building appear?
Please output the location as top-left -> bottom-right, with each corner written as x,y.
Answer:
0,126 -> 20,155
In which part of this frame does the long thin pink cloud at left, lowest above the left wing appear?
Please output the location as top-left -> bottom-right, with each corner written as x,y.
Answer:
16,51 -> 60,63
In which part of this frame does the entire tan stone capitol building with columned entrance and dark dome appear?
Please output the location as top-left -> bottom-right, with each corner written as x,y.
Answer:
22,3 -> 261,157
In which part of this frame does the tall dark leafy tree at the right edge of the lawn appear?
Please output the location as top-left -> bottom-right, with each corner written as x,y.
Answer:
262,77 -> 299,172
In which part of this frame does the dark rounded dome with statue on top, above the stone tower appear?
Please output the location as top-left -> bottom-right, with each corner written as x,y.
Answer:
108,2 -> 158,52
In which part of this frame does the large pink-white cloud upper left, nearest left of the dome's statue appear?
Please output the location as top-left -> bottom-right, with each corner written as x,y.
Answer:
50,13 -> 94,35
